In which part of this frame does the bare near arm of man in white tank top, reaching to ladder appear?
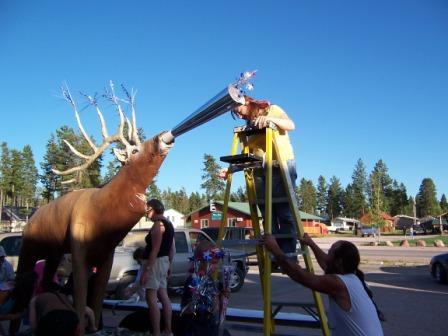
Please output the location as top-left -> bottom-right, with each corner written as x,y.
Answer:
260,234 -> 346,297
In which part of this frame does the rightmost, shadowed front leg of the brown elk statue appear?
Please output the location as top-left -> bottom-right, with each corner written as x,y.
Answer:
88,251 -> 114,328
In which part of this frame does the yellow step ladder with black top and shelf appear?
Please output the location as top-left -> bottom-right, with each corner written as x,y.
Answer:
218,123 -> 330,336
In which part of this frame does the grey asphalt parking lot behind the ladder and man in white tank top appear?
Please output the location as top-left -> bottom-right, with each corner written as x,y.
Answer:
101,242 -> 448,336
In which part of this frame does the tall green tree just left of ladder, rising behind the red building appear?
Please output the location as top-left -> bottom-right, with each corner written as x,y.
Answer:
201,154 -> 225,201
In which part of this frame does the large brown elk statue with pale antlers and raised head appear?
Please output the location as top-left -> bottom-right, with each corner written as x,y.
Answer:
17,83 -> 174,332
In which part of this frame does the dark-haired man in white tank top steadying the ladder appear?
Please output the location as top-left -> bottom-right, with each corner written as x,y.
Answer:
260,233 -> 384,336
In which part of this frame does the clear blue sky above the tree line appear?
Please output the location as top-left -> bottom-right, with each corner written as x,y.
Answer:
0,0 -> 448,198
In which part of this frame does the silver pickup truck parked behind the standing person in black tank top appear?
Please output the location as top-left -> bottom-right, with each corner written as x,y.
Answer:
58,229 -> 248,299
